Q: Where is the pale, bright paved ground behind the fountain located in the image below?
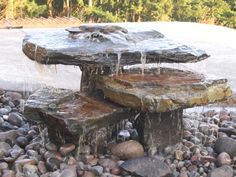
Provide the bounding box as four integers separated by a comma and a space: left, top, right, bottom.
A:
0, 22, 236, 91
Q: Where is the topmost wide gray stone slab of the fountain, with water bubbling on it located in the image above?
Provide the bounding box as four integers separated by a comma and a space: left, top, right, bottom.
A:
23, 25, 209, 66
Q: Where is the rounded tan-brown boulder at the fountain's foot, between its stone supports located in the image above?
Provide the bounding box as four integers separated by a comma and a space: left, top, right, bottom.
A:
111, 140, 144, 160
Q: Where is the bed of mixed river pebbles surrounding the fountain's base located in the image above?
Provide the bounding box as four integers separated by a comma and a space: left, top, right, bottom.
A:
0, 90, 236, 177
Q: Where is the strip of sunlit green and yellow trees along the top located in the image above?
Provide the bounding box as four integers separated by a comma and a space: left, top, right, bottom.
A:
0, 0, 236, 28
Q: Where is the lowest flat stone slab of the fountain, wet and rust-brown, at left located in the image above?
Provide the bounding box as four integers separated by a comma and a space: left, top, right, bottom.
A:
25, 88, 128, 135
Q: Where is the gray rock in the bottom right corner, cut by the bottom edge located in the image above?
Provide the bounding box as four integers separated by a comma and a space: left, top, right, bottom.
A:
210, 165, 233, 177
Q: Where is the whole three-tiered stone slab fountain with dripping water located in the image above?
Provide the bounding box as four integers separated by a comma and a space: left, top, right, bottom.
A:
23, 25, 231, 152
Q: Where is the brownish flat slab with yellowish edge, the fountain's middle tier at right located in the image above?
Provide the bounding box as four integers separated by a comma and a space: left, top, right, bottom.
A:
96, 68, 232, 112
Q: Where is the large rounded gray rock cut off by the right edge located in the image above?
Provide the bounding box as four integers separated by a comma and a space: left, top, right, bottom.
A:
215, 137, 236, 157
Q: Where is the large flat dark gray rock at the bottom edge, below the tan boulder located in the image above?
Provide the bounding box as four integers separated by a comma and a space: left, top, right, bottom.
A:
120, 157, 171, 177
